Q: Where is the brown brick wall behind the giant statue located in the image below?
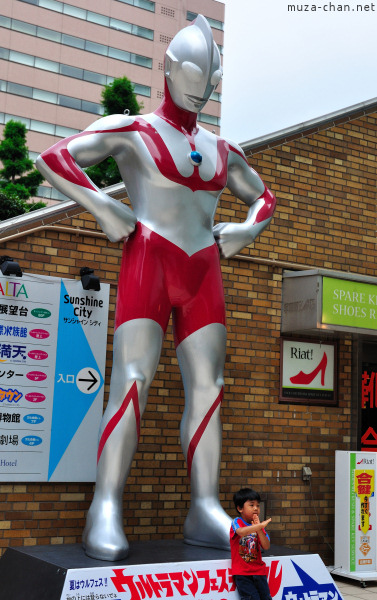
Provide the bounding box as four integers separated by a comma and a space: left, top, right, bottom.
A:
0, 114, 377, 564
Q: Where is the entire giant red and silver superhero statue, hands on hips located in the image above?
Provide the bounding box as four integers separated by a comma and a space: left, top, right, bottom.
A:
37, 15, 275, 560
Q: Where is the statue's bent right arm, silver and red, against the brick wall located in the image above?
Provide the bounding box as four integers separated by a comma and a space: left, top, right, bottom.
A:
213, 145, 276, 258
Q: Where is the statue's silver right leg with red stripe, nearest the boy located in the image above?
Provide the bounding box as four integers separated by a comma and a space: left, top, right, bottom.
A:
177, 323, 231, 549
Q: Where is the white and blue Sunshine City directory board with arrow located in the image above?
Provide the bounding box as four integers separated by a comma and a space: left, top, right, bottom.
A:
0, 275, 109, 481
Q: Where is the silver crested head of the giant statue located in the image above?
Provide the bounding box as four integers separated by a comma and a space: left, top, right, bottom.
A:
165, 15, 222, 113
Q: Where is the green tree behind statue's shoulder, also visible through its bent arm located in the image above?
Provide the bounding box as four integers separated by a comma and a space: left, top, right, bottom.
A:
85, 77, 143, 187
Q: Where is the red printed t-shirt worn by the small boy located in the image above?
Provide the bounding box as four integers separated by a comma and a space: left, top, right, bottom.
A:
230, 517, 268, 575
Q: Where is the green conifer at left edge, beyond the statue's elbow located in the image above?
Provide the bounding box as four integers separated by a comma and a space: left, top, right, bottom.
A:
0, 121, 43, 200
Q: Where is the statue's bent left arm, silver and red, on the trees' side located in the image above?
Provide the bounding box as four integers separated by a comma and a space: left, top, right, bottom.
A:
36, 115, 136, 242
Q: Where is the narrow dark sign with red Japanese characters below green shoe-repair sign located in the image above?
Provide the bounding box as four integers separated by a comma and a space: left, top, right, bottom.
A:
360, 363, 377, 452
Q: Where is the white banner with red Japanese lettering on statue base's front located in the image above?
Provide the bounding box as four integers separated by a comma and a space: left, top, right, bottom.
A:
61, 542, 342, 600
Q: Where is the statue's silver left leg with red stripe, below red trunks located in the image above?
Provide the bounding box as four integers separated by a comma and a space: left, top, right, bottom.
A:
83, 319, 164, 560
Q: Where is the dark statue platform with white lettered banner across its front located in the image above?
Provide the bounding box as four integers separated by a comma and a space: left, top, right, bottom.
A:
0, 540, 341, 600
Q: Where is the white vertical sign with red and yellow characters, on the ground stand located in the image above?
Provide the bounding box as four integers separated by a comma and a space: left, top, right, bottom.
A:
350, 453, 376, 572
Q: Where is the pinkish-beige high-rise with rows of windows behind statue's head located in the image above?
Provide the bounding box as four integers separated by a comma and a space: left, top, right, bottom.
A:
0, 0, 224, 203
